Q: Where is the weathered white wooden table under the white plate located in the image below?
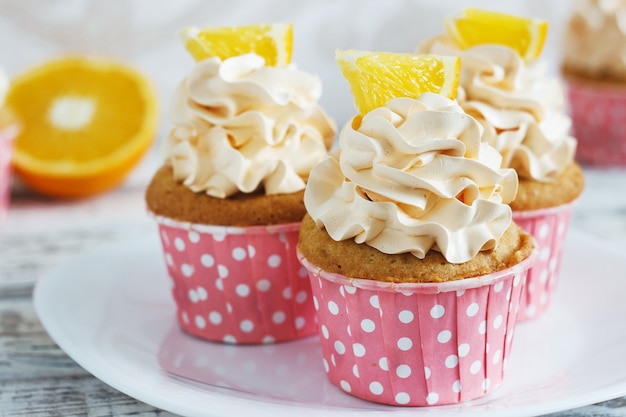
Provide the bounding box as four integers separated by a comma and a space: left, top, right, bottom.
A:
0, 150, 626, 417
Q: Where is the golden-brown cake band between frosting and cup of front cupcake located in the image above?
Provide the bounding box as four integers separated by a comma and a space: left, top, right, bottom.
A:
298, 214, 533, 283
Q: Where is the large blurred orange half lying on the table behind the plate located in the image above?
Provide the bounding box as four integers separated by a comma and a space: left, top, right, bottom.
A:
6, 56, 157, 197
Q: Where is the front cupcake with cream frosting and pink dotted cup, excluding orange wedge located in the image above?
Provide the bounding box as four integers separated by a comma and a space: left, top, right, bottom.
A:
298, 50, 533, 406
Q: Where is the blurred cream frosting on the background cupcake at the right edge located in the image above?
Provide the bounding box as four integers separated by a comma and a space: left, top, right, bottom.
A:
563, 0, 626, 81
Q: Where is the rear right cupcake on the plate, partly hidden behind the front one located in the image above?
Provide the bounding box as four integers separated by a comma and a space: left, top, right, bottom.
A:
418, 12, 584, 320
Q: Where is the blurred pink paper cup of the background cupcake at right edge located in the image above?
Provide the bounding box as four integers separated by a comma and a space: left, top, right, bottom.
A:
568, 81, 626, 167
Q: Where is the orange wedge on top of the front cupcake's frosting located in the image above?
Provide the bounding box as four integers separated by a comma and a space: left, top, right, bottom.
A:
335, 49, 461, 115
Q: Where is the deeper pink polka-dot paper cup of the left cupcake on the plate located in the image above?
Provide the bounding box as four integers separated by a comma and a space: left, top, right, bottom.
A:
155, 213, 317, 344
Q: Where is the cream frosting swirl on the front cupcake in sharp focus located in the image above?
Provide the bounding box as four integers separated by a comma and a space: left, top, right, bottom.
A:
304, 93, 517, 263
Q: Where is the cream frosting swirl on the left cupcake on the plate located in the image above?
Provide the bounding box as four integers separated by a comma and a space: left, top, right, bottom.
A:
163, 54, 336, 198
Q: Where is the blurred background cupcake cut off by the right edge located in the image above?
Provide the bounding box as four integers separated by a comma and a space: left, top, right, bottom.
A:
561, 0, 626, 168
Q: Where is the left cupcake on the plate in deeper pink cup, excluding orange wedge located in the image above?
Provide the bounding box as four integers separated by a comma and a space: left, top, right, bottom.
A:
145, 26, 335, 344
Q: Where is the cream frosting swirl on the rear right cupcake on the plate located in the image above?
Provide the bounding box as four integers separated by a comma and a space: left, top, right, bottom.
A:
419, 36, 576, 182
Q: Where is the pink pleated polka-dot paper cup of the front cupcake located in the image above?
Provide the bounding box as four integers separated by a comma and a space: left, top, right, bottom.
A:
301, 252, 533, 406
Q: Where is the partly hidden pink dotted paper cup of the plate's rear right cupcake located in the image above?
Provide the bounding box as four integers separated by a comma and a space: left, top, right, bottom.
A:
513, 203, 574, 321
